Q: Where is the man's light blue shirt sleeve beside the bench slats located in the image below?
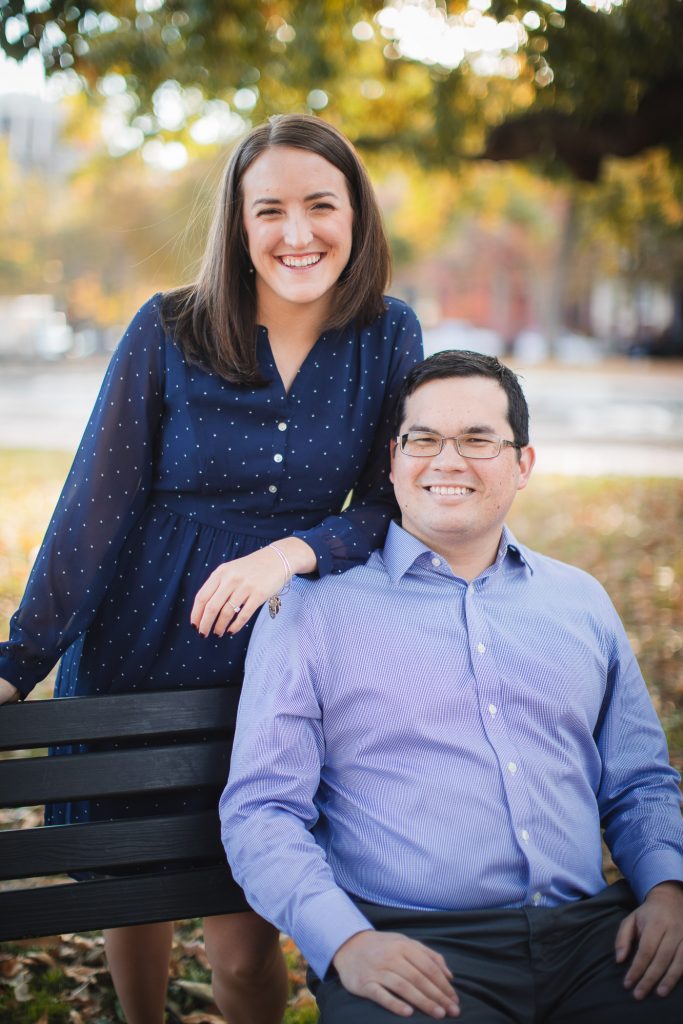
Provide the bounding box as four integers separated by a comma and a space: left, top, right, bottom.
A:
220, 581, 372, 978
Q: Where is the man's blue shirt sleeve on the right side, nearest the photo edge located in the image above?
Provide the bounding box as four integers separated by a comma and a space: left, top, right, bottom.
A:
596, 604, 683, 901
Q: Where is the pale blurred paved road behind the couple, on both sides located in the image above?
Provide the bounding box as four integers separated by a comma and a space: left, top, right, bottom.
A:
0, 359, 683, 478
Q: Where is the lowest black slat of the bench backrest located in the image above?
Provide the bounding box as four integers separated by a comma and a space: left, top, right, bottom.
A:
0, 865, 244, 941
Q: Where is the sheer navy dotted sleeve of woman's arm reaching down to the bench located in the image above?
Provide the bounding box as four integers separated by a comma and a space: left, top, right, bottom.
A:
0, 299, 164, 696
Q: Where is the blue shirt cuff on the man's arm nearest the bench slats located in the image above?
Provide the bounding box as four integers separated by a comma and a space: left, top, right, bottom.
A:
292, 889, 374, 979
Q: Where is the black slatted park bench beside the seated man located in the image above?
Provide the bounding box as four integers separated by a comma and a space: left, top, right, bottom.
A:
0, 689, 242, 941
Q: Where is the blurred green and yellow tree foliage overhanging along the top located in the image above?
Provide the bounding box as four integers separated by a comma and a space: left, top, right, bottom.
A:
5, 0, 683, 180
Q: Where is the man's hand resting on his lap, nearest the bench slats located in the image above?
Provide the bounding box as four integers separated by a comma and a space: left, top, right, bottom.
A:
333, 931, 460, 1020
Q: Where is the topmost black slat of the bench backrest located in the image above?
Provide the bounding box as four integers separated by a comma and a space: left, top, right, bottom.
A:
0, 687, 240, 751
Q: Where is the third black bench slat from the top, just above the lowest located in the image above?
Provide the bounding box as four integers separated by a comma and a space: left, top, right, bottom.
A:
0, 815, 225, 879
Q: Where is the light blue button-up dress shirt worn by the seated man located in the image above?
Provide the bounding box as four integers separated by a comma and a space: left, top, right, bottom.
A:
220, 523, 683, 977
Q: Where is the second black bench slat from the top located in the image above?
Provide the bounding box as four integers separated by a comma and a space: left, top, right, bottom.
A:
0, 737, 230, 807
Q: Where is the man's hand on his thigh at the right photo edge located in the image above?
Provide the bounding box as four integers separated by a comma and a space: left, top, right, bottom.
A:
614, 882, 683, 999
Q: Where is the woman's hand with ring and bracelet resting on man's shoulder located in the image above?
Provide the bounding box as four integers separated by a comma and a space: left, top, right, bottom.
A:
189, 537, 316, 637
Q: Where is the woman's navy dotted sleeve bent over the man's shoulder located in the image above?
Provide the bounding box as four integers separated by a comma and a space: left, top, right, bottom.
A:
294, 303, 423, 575
